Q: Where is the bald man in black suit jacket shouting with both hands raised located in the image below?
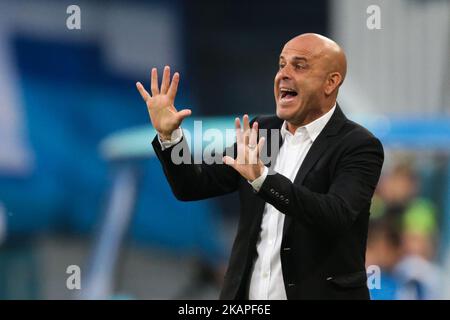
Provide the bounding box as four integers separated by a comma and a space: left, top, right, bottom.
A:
137, 34, 384, 300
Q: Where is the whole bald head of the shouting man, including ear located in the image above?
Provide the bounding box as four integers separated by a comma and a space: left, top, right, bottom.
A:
274, 33, 347, 127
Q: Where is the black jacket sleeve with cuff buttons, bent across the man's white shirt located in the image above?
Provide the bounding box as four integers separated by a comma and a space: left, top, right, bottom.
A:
258, 136, 384, 234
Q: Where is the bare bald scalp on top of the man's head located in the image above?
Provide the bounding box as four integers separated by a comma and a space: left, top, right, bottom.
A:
283, 33, 347, 85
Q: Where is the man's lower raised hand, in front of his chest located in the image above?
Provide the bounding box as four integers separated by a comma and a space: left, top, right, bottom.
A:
223, 115, 264, 181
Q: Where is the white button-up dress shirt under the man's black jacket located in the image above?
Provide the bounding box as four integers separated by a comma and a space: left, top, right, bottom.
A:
248, 105, 336, 300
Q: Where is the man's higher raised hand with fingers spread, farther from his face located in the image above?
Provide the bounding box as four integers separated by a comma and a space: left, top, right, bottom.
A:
136, 66, 192, 140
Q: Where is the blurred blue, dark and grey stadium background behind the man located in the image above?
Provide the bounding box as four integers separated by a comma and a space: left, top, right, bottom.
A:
0, 0, 450, 299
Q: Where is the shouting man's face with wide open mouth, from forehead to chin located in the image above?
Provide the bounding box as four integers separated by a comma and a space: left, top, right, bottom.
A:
274, 43, 325, 125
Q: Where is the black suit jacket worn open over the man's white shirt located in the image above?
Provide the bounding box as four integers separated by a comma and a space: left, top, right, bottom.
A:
152, 106, 384, 299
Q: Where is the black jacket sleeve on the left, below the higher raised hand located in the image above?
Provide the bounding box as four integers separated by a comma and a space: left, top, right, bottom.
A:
152, 132, 239, 201
